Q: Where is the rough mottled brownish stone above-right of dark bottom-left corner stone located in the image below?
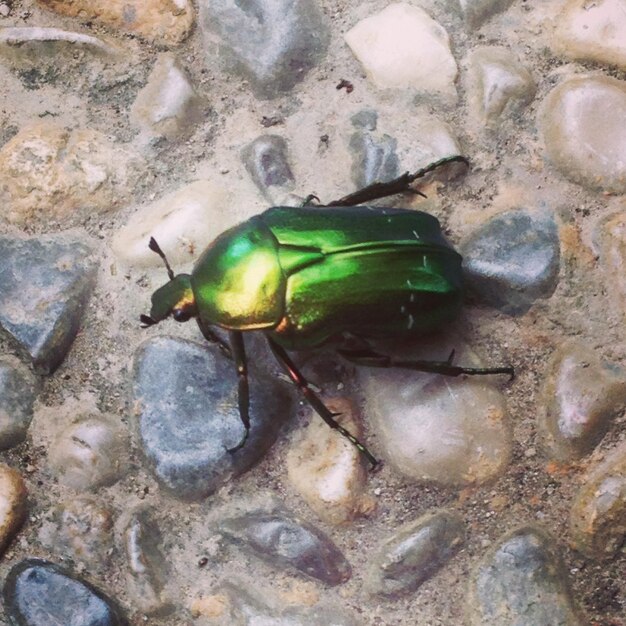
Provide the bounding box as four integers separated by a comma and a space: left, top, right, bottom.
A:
38, 496, 114, 572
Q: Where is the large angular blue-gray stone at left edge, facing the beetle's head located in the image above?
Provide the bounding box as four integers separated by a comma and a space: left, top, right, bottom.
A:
0, 233, 96, 374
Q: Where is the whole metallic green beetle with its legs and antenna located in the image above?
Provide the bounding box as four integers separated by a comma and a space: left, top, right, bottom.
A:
141, 156, 513, 466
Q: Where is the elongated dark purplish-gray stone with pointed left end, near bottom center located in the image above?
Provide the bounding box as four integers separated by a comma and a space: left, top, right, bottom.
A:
220, 511, 350, 586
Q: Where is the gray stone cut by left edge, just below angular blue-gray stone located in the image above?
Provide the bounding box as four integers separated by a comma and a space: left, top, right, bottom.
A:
0, 357, 39, 450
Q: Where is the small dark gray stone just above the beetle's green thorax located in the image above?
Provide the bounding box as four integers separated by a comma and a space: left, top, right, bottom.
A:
241, 135, 294, 201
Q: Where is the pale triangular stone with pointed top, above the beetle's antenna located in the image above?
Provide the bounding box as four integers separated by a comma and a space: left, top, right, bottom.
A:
130, 52, 202, 140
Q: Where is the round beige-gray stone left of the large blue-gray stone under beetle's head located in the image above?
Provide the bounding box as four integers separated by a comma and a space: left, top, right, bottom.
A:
50, 416, 129, 491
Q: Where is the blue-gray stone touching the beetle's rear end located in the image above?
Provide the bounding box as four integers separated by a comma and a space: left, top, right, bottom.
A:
461, 210, 560, 315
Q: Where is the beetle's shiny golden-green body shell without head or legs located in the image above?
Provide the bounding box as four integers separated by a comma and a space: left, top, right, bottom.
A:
191, 206, 461, 349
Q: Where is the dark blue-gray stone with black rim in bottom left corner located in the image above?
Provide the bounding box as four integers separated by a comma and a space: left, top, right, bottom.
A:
2, 559, 128, 626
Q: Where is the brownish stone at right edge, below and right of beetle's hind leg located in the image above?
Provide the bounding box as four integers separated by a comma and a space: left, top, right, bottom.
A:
539, 344, 626, 461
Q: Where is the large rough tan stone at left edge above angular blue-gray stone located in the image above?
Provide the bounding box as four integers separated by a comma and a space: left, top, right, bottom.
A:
0, 122, 140, 227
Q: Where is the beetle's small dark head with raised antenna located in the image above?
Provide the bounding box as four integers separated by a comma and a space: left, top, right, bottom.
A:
140, 238, 197, 328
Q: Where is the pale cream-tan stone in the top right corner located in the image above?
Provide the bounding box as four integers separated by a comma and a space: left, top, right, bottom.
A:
550, 0, 626, 69
